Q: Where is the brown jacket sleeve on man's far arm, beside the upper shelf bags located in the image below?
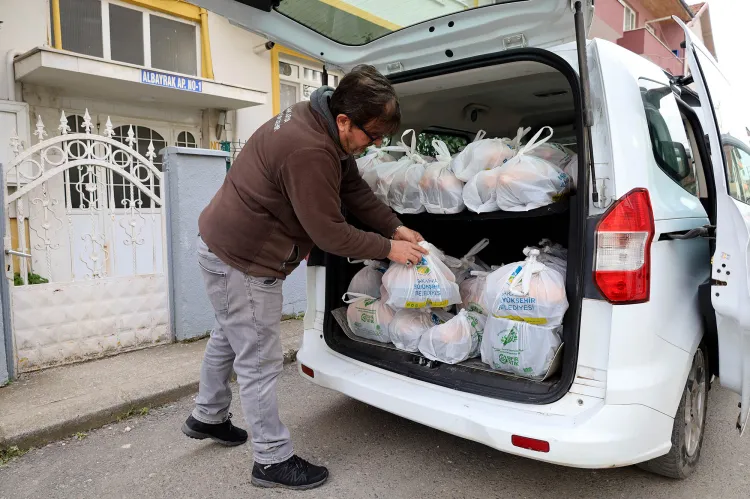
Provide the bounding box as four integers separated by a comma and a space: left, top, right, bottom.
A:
341, 161, 401, 237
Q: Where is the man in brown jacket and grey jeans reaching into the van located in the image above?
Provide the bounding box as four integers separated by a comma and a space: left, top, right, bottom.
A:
182, 66, 426, 489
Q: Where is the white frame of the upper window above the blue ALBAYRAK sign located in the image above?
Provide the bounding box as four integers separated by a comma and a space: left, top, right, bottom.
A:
53, 0, 203, 78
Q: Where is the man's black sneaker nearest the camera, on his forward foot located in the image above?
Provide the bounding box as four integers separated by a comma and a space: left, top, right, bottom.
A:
250, 455, 328, 490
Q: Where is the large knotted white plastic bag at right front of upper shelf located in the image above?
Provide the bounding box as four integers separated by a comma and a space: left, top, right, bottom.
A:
496, 126, 570, 211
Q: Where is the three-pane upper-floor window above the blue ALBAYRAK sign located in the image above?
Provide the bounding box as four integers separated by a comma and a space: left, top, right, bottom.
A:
50, 0, 200, 76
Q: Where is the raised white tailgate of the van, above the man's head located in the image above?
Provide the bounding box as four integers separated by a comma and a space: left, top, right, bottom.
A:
193, 0, 594, 74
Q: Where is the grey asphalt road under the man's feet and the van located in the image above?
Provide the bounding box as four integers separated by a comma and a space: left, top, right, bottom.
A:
0, 366, 750, 499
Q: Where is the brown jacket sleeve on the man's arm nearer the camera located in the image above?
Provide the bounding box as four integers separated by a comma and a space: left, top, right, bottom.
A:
279, 148, 391, 260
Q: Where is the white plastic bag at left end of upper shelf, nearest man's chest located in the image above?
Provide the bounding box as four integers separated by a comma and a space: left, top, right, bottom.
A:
376, 130, 427, 214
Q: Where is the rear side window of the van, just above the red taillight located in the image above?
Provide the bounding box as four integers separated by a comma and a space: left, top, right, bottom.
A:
638, 79, 698, 196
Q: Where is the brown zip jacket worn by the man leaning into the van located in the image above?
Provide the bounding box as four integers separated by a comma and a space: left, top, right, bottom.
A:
198, 97, 400, 279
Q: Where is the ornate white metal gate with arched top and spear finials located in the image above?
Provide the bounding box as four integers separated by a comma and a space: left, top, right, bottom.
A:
2, 111, 170, 372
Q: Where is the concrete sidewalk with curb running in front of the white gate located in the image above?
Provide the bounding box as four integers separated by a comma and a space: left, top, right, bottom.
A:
0, 320, 303, 449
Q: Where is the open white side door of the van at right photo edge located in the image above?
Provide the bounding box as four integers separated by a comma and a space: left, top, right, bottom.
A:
677, 20, 750, 433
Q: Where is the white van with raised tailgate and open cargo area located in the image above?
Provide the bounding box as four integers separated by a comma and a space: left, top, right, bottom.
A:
196, 0, 750, 478
